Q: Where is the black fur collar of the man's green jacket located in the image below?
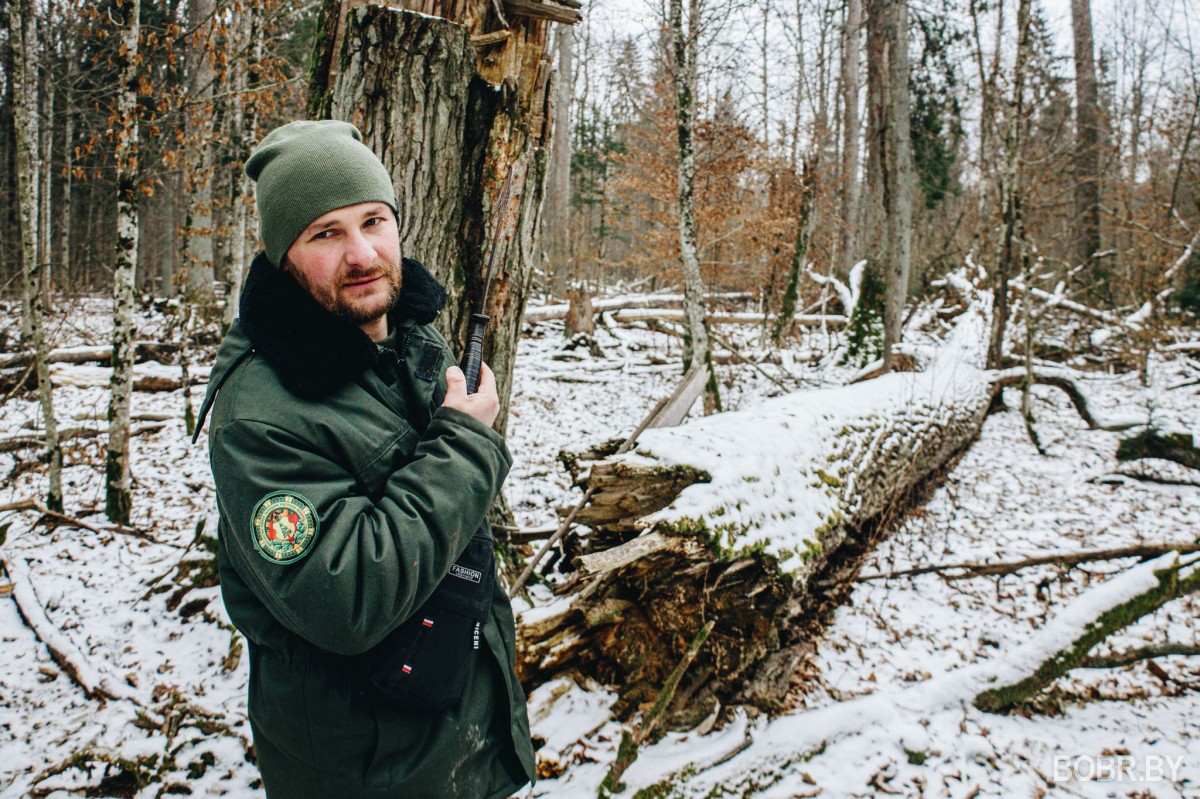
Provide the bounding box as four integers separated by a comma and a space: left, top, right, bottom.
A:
238, 253, 446, 398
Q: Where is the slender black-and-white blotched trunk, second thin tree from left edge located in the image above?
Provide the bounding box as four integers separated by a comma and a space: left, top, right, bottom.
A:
104, 0, 142, 524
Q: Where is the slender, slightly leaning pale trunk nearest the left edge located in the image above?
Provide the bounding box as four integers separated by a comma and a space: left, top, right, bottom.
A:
8, 0, 62, 511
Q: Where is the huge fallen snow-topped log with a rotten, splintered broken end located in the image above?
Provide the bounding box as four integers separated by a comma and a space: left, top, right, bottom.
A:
521, 307, 995, 717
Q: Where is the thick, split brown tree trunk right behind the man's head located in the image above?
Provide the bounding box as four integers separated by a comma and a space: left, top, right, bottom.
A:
308, 0, 573, 432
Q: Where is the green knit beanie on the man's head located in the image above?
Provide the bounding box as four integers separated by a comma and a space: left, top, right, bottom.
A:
246, 120, 397, 266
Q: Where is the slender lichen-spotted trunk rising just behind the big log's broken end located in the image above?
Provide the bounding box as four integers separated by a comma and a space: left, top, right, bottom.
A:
668, 0, 721, 413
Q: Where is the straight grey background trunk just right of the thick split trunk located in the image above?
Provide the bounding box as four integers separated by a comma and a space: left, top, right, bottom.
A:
542, 28, 575, 283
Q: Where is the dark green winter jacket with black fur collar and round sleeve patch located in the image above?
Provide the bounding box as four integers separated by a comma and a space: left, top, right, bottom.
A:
197, 250, 534, 799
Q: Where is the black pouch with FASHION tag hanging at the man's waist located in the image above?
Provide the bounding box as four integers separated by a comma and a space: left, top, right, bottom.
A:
362, 522, 496, 710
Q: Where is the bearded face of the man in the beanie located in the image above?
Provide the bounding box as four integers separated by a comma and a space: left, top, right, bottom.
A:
283, 203, 401, 325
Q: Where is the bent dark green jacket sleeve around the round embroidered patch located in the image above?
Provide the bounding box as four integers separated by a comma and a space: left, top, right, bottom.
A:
210, 407, 512, 655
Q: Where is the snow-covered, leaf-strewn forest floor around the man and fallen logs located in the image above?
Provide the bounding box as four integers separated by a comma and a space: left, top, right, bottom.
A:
0, 300, 1200, 798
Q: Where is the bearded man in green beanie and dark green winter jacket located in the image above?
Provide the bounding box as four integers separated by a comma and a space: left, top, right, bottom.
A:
190, 121, 534, 799
